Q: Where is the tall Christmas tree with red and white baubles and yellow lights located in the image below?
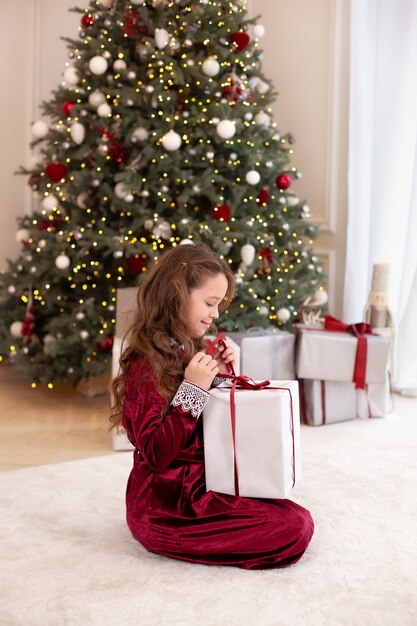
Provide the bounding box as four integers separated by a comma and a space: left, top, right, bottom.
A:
0, 0, 326, 385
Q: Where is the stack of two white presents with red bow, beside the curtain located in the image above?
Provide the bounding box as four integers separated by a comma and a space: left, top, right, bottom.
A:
296, 316, 390, 426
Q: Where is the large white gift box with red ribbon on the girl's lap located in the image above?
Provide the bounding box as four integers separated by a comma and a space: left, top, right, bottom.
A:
203, 380, 301, 499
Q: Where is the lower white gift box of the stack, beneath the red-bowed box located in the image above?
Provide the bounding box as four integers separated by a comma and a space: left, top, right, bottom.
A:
299, 379, 389, 426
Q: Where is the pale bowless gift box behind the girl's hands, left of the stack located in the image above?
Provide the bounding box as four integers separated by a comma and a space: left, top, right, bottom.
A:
241, 331, 295, 380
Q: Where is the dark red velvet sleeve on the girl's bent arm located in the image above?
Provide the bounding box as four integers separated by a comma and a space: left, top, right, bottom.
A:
123, 360, 206, 472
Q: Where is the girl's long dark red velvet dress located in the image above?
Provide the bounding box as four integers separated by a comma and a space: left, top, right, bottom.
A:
123, 359, 314, 569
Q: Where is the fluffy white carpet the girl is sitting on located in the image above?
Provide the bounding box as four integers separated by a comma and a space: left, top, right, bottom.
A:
0, 400, 417, 626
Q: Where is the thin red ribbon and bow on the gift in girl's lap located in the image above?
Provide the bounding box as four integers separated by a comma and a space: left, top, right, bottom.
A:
214, 339, 295, 496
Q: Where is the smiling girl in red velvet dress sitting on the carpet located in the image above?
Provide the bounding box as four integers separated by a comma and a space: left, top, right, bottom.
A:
111, 244, 313, 569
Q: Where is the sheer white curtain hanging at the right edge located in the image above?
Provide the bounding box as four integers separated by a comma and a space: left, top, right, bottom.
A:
344, 0, 417, 390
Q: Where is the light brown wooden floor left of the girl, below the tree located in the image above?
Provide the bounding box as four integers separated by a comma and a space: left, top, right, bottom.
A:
0, 365, 117, 471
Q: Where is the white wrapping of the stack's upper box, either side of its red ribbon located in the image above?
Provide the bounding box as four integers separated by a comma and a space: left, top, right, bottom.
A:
296, 329, 390, 384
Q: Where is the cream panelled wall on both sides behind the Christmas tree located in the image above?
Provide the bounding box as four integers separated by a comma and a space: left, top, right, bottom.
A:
0, 0, 349, 315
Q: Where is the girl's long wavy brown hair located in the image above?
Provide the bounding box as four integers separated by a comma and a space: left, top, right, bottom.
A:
110, 244, 235, 427
